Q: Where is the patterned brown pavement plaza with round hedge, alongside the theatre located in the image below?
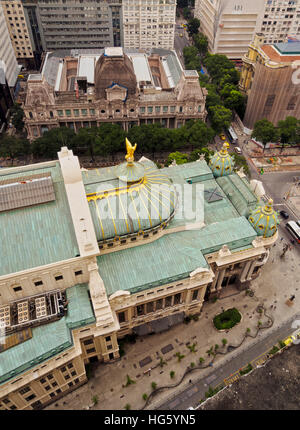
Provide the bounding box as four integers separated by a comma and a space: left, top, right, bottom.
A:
46, 237, 300, 410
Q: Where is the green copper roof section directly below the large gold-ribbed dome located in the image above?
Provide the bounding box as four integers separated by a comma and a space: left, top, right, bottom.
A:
97, 233, 208, 296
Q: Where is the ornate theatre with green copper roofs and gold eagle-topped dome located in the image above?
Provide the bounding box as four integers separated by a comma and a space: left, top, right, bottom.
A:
0, 137, 278, 410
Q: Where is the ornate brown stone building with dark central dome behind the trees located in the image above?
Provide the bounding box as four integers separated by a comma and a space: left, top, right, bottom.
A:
24, 48, 206, 140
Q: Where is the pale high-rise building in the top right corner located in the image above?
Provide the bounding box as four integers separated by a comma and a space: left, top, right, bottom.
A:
195, 0, 300, 59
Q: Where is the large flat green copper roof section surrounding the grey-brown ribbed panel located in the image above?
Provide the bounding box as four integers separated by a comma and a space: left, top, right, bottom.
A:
0, 163, 79, 276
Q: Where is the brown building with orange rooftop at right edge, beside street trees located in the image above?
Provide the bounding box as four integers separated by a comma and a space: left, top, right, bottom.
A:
239, 33, 300, 130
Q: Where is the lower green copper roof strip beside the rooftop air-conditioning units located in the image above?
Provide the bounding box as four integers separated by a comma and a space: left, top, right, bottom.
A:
0, 284, 95, 384
